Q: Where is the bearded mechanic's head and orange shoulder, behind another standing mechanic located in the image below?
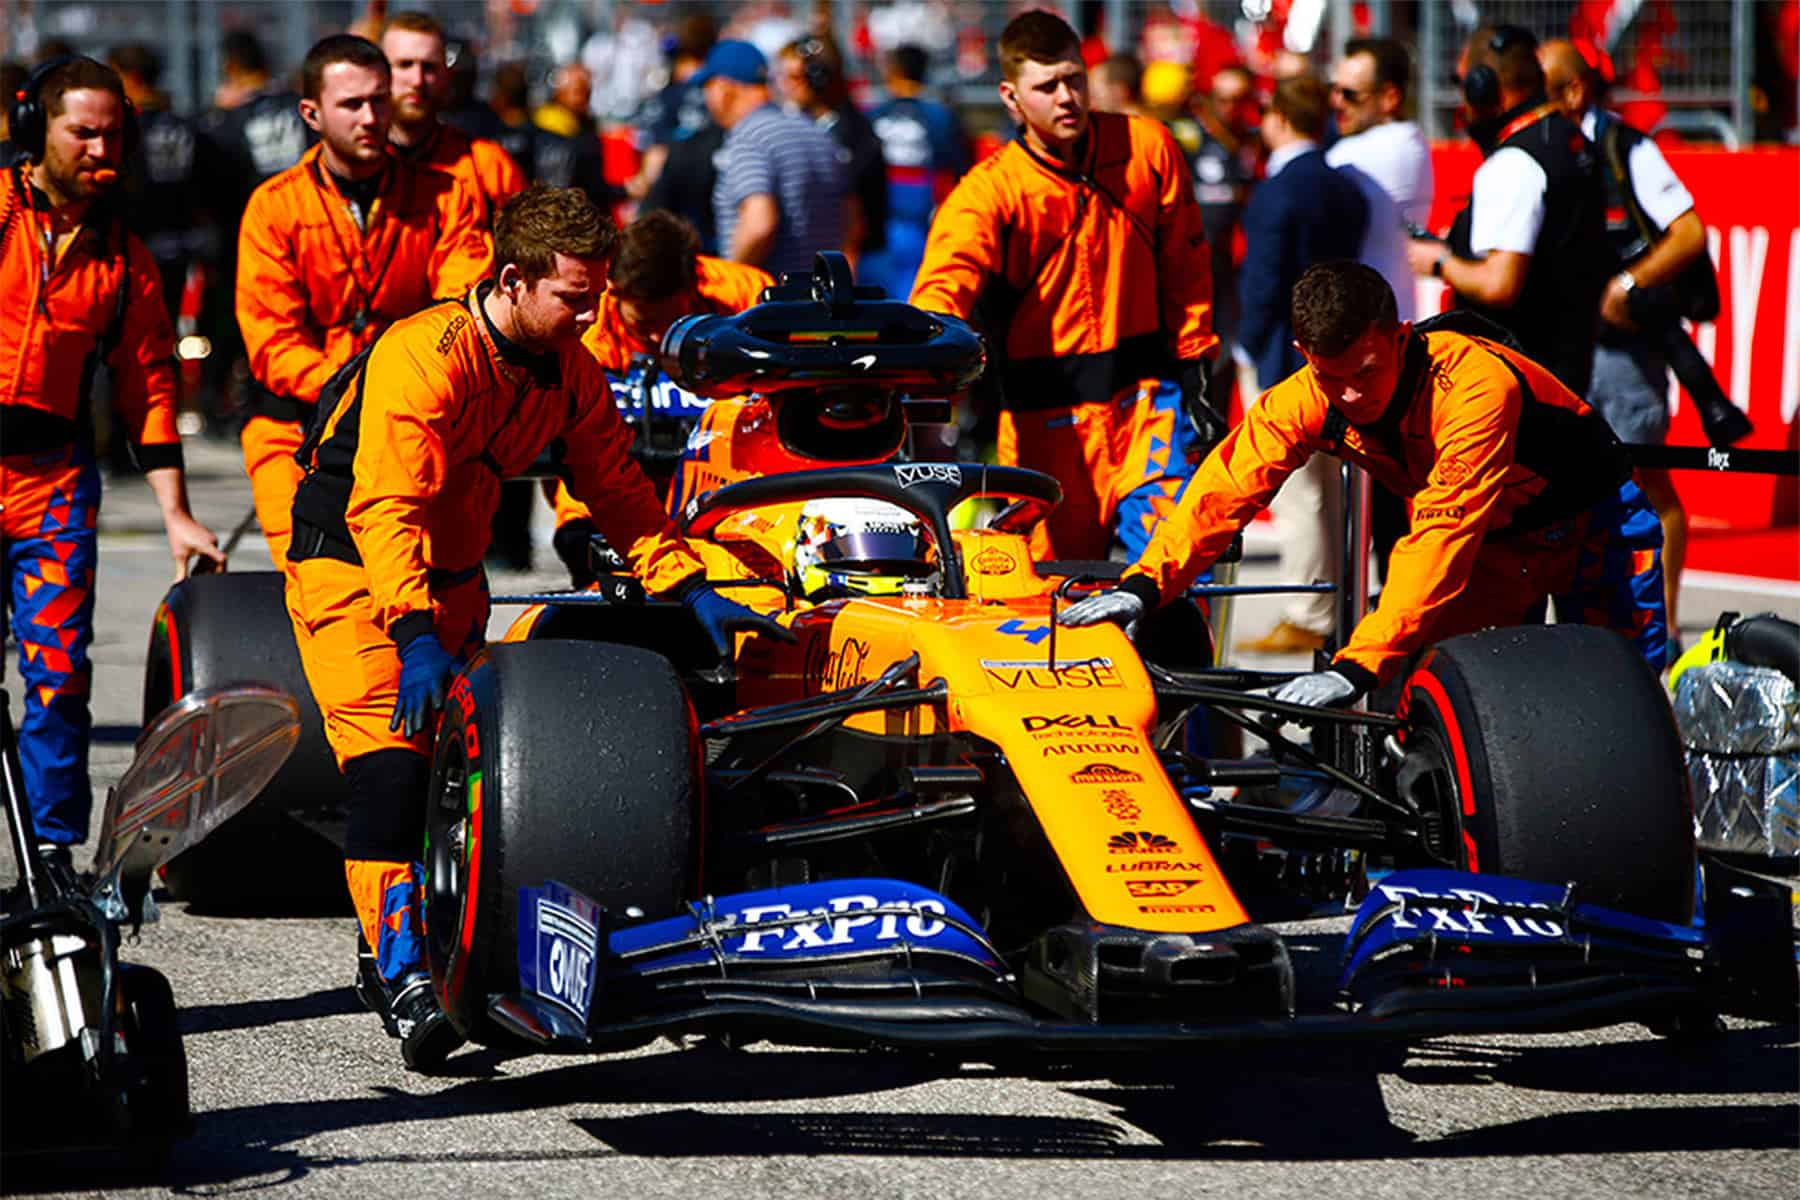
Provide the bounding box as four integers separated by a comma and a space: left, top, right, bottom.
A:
382, 13, 526, 227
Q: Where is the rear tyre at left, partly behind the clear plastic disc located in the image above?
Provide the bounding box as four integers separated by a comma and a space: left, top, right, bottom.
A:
144, 570, 347, 912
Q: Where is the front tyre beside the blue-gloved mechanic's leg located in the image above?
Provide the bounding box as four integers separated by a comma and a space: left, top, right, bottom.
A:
425, 640, 700, 1045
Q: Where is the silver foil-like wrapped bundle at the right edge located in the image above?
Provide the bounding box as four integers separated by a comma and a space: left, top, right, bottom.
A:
1676, 662, 1800, 856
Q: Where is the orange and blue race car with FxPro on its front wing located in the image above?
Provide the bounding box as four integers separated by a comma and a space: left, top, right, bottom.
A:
136, 255, 1795, 1052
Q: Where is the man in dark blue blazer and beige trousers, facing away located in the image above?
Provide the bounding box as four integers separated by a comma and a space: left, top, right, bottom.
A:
1238, 76, 1368, 653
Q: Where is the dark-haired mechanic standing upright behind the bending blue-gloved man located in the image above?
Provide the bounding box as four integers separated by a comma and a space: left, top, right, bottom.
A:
238, 34, 493, 567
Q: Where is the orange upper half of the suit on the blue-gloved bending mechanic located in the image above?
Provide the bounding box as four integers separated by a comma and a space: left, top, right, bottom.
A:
290, 284, 702, 630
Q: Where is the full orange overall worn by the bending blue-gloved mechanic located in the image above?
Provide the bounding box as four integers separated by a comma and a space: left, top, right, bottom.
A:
286, 284, 702, 982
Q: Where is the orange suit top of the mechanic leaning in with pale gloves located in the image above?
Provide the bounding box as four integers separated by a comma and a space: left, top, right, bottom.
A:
1125, 331, 1629, 684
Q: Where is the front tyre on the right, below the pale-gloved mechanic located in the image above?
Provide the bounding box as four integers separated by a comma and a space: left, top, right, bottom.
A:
1397, 624, 1694, 923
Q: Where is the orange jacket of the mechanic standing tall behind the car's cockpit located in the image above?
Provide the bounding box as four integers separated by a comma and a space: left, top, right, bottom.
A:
913, 113, 1219, 410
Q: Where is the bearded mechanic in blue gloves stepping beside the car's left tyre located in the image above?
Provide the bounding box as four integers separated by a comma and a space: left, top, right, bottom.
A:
286, 187, 792, 1069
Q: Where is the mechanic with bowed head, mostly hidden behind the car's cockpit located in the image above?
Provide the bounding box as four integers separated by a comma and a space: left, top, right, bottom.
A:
554, 210, 774, 587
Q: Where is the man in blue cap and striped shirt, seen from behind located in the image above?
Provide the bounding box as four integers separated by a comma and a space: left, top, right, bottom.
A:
693, 41, 850, 277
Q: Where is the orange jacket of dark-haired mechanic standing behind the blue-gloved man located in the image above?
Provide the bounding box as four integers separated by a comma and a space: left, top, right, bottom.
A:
238, 146, 493, 405
